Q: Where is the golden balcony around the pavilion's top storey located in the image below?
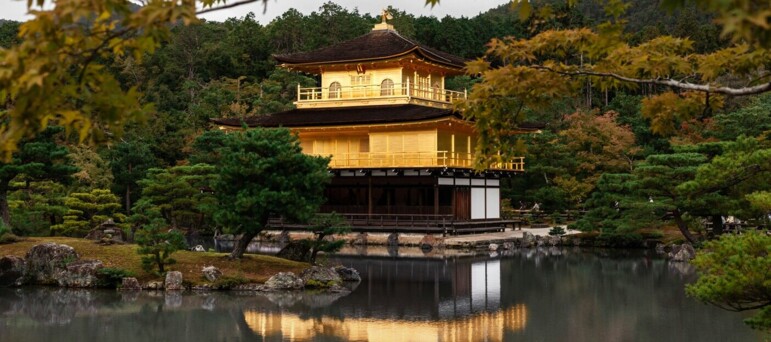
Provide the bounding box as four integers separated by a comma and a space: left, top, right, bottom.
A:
295, 82, 466, 108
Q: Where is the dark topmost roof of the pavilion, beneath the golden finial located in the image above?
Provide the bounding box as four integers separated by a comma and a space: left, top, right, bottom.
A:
273, 30, 466, 69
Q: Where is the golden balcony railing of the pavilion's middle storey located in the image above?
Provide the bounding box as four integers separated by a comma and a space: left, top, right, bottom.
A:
314, 151, 525, 172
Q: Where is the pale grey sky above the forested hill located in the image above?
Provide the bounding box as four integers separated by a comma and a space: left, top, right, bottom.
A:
0, 0, 510, 25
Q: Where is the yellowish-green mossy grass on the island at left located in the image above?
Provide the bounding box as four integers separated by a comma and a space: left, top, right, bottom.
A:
0, 237, 308, 284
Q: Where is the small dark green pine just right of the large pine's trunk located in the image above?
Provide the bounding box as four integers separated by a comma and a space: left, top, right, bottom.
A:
306, 212, 351, 265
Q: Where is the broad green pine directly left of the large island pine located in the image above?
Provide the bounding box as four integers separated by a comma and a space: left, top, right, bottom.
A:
132, 164, 216, 234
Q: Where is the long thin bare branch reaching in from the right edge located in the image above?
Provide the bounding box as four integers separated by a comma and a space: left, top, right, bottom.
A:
529, 65, 771, 96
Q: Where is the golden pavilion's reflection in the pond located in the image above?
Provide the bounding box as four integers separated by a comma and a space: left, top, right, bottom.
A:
244, 258, 528, 341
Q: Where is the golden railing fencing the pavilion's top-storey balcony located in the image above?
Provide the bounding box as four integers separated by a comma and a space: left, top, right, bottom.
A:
297, 82, 466, 103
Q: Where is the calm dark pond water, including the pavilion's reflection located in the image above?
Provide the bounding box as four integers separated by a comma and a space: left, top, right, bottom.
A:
0, 249, 768, 342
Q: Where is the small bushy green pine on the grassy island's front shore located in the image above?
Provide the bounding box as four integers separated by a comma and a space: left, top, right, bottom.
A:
134, 213, 186, 274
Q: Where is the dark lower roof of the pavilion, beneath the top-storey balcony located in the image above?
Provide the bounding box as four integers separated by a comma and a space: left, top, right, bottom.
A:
211, 104, 460, 127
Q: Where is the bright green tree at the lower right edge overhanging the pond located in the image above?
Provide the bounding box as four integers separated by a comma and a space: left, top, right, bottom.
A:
686, 232, 771, 330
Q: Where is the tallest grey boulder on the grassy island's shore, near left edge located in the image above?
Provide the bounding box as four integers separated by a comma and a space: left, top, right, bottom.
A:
24, 243, 80, 285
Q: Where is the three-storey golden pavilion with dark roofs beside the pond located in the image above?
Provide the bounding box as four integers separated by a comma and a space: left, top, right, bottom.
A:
213, 13, 527, 233
